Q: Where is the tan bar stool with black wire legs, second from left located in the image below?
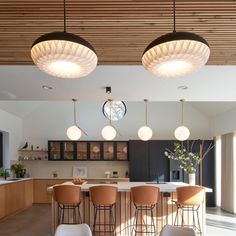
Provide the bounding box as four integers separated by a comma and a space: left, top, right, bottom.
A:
89, 185, 117, 235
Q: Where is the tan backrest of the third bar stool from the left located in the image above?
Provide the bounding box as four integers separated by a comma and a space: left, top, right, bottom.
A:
131, 185, 160, 205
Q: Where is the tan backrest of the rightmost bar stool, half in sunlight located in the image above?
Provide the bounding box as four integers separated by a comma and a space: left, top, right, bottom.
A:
176, 186, 205, 205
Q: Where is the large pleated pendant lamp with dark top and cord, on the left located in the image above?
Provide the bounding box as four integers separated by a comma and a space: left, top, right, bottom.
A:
31, 0, 98, 79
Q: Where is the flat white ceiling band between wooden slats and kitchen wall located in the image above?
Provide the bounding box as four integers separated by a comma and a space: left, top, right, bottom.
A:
0, 66, 236, 101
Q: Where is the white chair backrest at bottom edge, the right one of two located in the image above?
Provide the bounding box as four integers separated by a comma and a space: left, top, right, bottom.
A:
160, 225, 196, 236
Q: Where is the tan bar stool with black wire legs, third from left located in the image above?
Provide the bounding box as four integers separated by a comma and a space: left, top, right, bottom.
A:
131, 186, 160, 235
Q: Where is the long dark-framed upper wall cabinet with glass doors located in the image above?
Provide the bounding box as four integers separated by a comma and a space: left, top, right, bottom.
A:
48, 140, 128, 161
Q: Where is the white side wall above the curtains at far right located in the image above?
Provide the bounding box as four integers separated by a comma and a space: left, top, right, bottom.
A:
211, 108, 236, 136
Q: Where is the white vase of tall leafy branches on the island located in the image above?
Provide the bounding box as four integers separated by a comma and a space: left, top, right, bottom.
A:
165, 141, 214, 185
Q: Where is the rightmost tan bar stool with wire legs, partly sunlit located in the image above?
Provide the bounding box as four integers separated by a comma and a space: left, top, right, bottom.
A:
174, 186, 205, 235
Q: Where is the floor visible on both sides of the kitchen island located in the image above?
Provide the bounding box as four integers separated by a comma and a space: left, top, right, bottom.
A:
0, 204, 236, 236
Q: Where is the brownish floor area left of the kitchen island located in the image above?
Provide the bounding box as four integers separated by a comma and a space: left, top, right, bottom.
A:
0, 204, 51, 236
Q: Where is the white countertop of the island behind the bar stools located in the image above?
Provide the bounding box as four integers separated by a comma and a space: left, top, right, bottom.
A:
48, 182, 212, 192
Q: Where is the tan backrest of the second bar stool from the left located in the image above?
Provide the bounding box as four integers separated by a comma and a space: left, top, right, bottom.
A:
89, 185, 117, 206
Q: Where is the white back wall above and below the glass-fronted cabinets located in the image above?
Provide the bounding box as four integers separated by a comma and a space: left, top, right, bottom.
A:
19, 101, 210, 177
